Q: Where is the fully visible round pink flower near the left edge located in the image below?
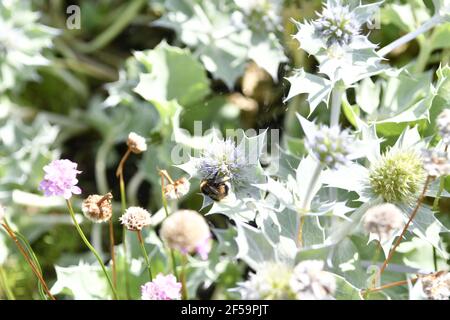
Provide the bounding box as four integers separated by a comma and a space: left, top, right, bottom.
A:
39, 159, 81, 199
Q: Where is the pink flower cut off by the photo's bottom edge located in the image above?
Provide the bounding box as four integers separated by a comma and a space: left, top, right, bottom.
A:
141, 273, 181, 300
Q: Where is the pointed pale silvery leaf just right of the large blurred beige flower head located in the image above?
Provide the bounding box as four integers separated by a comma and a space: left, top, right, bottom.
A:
236, 221, 276, 270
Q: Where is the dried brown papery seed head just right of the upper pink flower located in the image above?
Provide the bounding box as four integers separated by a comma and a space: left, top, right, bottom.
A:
81, 192, 113, 223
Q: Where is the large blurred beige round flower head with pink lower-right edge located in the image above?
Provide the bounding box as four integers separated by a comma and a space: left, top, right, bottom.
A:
160, 210, 211, 259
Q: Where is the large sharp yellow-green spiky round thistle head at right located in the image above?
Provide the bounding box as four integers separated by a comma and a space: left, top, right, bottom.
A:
369, 150, 426, 203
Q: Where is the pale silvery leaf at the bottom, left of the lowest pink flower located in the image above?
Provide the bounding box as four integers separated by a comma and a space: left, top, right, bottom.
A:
50, 262, 111, 300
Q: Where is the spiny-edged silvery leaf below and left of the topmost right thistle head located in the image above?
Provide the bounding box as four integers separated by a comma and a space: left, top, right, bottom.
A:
284, 69, 333, 115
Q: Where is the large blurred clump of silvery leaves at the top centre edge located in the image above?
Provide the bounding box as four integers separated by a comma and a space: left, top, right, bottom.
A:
153, 0, 286, 88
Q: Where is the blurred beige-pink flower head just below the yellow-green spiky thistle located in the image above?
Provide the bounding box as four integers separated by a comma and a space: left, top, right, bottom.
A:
364, 203, 403, 242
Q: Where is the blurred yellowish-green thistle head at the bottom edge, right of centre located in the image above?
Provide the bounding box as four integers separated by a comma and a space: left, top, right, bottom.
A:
237, 262, 295, 300
